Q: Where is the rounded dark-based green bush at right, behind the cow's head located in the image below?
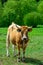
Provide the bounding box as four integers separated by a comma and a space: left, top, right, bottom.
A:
23, 12, 42, 27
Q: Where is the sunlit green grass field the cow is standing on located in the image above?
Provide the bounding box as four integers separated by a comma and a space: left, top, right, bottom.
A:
0, 28, 43, 65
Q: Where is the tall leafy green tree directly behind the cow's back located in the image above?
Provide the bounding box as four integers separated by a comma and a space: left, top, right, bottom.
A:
2, 1, 23, 26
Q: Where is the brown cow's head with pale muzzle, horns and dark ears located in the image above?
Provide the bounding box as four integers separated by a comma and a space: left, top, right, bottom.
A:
17, 26, 32, 41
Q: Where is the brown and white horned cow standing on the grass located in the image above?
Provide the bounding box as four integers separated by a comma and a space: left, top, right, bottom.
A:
6, 23, 32, 61
